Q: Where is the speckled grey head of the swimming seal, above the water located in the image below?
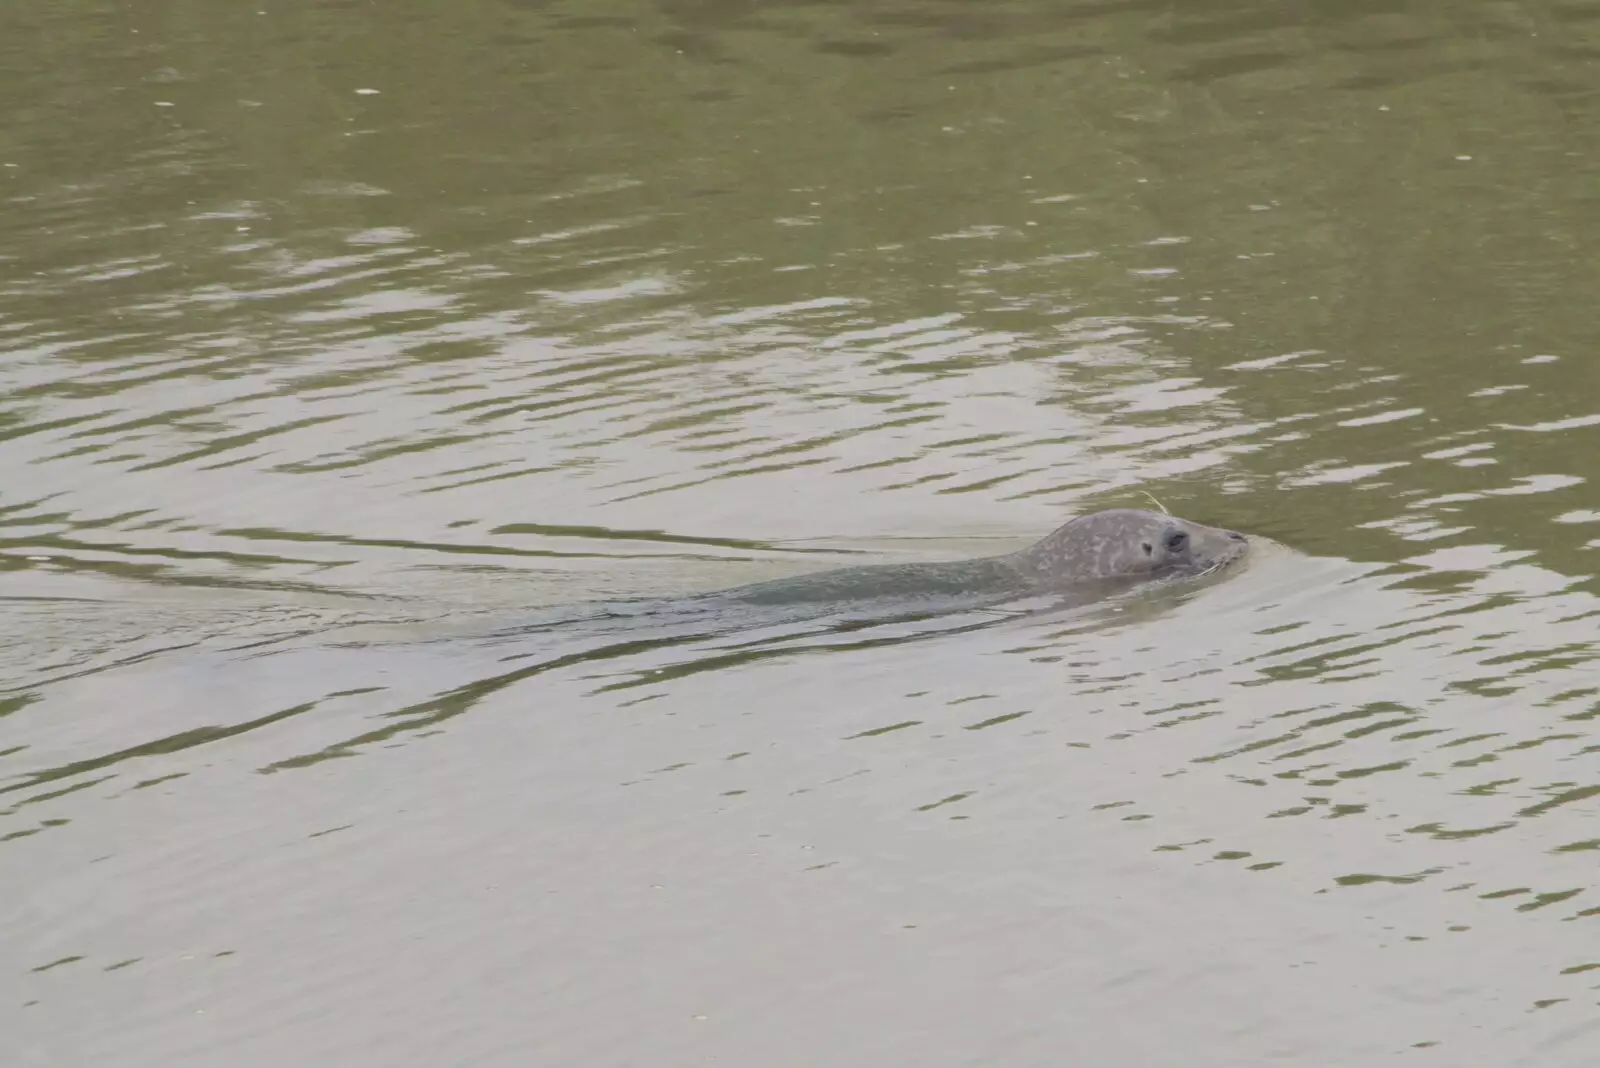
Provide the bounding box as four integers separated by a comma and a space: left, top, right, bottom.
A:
1013, 508, 1250, 590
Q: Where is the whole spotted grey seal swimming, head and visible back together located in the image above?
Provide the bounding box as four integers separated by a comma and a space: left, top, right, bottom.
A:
715, 508, 1250, 604
